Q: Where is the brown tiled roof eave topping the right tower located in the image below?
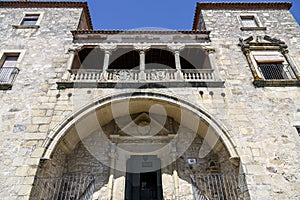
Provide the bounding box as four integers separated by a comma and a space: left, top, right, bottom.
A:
193, 2, 292, 30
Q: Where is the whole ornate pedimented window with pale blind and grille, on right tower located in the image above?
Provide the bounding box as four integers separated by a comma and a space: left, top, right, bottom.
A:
240, 36, 300, 86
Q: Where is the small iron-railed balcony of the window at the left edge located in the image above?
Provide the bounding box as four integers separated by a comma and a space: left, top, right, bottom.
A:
0, 67, 20, 90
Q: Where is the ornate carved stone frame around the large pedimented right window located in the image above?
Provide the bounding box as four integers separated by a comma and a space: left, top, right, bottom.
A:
240, 36, 300, 87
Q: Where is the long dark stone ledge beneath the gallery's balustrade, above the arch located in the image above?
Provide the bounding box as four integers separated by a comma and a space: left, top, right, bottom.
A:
56, 81, 224, 89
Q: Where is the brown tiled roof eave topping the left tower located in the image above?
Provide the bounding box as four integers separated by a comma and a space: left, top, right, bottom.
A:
0, 1, 93, 29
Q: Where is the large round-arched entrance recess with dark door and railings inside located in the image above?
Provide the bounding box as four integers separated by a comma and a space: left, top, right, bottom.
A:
32, 92, 246, 199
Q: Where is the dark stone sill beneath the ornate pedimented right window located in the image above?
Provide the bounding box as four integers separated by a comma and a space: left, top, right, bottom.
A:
253, 80, 300, 87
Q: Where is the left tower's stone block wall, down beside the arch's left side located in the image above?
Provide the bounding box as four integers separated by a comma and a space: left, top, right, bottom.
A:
0, 8, 82, 199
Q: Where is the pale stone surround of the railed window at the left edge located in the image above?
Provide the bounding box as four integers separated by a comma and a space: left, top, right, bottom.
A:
0, 50, 25, 90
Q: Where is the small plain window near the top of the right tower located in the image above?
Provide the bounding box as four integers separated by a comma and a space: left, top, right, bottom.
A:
239, 15, 266, 31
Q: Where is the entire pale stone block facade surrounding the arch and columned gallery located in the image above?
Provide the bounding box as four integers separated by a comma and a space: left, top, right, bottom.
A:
0, 3, 300, 199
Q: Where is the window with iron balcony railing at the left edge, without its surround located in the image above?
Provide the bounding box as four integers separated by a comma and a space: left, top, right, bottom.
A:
0, 53, 20, 89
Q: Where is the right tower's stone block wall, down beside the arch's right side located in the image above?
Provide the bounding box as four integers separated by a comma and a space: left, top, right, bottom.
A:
197, 9, 300, 199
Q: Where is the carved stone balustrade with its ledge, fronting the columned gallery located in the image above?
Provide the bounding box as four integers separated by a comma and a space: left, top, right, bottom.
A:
57, 69, 223, 88
